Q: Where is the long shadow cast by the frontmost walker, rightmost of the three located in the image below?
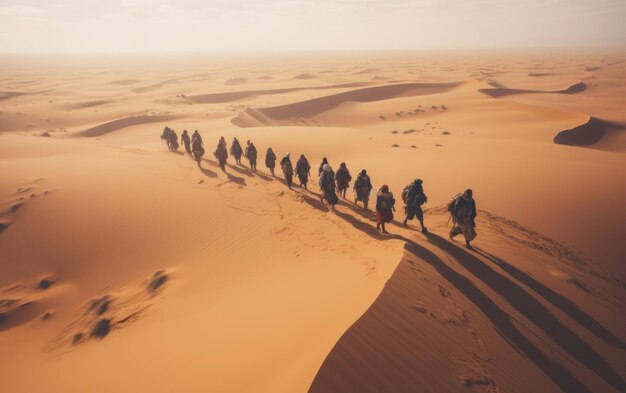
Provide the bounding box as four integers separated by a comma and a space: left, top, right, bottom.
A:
476, 249, 626, 349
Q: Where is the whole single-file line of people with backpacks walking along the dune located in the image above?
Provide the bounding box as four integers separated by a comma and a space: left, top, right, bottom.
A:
161, 127, 476, 248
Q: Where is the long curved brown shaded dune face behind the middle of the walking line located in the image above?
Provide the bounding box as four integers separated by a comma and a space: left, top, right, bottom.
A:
232, 83, 459, 127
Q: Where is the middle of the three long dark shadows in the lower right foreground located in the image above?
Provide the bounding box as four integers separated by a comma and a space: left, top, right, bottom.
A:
427, 233, 626, 392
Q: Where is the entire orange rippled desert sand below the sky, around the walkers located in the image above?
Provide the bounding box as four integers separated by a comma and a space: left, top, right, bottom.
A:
0, 51, 626, 393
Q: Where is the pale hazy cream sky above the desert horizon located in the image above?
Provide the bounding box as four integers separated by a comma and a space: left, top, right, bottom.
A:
0, 0, 626, 52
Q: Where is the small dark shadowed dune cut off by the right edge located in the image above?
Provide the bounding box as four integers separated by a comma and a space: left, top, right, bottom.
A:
554, 117, 626, 151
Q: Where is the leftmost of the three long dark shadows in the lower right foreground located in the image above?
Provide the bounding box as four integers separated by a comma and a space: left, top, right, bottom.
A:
404, 235, 591, 393
